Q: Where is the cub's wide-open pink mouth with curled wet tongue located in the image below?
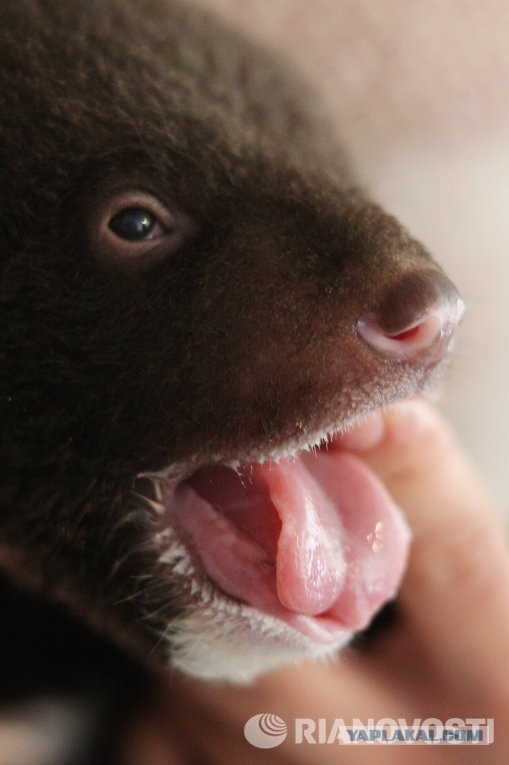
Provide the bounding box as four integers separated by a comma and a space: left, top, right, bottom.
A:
153, 424, 410, 645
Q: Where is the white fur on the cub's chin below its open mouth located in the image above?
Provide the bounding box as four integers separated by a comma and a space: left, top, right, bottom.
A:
149, 502, 351, 683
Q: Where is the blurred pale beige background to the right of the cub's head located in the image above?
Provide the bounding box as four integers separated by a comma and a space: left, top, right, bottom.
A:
200, 0, 509, 513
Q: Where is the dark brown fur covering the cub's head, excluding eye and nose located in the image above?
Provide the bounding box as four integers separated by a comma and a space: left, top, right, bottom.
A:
0, 0, 450, 760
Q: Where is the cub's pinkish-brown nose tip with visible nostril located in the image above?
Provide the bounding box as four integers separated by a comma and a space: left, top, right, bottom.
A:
357, 271, 465, 364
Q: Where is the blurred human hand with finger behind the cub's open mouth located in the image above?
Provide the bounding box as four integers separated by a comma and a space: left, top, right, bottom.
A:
122, 399, 509, 765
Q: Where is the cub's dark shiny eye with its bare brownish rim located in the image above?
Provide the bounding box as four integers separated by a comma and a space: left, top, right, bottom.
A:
90, 189, 196, 262
